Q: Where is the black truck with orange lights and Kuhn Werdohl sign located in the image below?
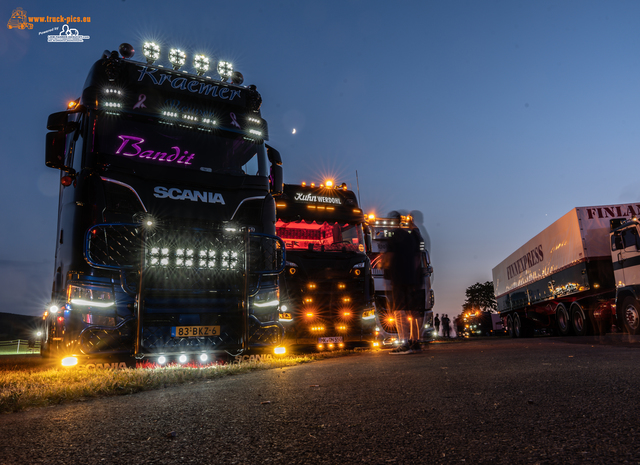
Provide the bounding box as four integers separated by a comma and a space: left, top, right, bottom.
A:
276, 181, 376, 350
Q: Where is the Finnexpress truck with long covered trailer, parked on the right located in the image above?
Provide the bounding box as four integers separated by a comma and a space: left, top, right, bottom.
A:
493, 204, 640, 337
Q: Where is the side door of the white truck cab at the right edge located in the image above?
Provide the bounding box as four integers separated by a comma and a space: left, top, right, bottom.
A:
611, 225, 640, 287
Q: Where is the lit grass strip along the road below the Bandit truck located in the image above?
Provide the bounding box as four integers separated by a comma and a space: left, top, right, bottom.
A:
0, 351, 353, 413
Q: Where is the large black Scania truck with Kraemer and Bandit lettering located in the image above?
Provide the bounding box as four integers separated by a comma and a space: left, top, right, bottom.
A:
42, 43, 285, 366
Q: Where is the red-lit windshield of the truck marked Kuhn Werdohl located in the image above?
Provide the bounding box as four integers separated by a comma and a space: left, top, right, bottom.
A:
276, 220, 364, 252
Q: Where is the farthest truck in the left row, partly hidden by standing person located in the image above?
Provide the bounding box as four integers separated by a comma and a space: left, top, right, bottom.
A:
367, 215, 435, 346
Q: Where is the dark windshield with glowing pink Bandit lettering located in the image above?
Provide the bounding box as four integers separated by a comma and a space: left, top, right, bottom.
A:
93, 114, 269, 176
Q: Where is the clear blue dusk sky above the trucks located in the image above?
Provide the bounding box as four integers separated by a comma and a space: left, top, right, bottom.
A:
0, 0, 640, 316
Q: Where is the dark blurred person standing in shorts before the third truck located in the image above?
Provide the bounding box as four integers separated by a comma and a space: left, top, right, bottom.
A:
384, 211, 422, 354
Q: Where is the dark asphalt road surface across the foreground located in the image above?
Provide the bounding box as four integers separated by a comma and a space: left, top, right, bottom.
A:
0, 337, 640, 464
